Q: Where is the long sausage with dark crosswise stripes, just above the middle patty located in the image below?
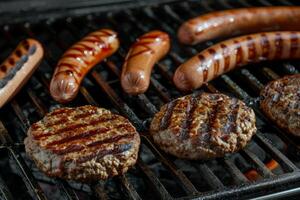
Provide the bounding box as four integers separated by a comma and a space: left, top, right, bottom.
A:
173, 32, 300, 91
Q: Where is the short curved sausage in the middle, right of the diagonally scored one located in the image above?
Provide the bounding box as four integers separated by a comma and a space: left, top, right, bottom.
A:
121, 31, 170, 95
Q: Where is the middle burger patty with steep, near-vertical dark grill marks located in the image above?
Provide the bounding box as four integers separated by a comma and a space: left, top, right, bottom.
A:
150, 93, 256, 160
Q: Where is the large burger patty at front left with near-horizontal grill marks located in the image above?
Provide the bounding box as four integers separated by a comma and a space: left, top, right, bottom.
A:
24, 106, 140, 181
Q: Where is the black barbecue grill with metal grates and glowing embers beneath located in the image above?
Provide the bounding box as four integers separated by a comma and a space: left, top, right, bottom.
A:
0, 0, 300, 200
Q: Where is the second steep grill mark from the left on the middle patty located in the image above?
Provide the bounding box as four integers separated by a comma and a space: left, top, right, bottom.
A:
179, 94, 199, 140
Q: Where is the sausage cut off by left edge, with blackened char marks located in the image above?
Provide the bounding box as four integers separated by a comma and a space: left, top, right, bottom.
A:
0, 39, 44, 108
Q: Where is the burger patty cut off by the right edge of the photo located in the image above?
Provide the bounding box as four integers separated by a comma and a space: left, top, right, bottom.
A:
260, 74, 300, 136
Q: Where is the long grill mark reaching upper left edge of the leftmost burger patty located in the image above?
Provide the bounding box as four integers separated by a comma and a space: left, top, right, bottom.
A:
34, 116, 117, 140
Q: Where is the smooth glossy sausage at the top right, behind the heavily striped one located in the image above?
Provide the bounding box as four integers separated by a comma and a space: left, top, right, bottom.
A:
178, 6, 300, 45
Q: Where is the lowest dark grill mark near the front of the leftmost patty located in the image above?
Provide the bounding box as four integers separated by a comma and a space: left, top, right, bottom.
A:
77, 143, 132, 163
